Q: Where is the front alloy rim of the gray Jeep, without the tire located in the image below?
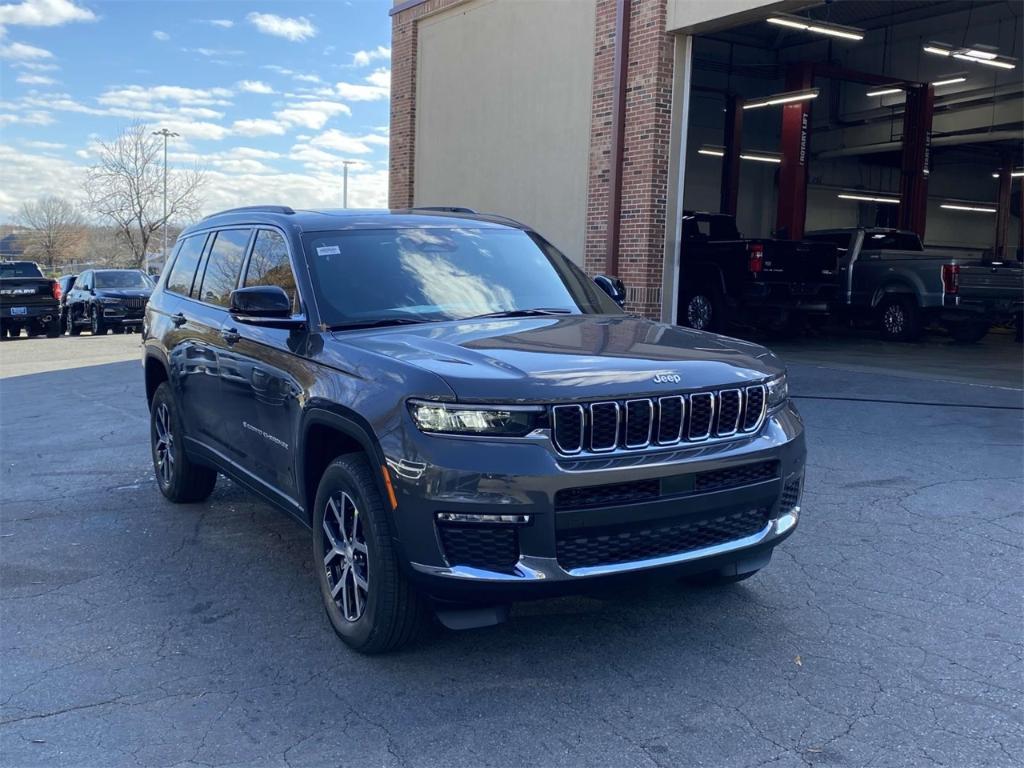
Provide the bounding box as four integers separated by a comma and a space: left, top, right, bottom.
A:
324, 490, 370, 622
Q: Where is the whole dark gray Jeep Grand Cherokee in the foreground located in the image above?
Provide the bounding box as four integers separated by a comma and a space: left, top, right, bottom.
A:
143, 207, 805, 652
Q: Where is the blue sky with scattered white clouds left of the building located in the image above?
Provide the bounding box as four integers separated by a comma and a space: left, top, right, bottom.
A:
0, 0, 391, 221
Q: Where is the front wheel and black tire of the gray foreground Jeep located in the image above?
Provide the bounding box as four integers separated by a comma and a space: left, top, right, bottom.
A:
312, 454, 428, 654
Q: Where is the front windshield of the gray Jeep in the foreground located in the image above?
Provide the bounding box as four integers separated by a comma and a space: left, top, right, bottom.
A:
303, 227, 621, 327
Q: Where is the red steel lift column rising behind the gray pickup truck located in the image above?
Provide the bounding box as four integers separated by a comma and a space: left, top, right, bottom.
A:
899, 85, 935, 240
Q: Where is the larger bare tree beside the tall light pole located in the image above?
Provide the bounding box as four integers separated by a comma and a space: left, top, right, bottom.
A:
85, 122, 206, 267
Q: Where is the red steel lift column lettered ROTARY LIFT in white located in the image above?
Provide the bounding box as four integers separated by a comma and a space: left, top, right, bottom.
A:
775, 63, 814, 240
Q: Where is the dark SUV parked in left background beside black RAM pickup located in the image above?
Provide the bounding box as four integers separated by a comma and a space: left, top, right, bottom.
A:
65, 269, 153, 336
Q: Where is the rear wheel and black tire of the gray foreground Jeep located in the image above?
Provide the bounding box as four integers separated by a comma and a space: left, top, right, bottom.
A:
150, 381, 217, 504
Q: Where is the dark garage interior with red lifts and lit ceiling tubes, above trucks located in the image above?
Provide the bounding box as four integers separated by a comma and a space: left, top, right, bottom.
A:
683, 0, 1024, 259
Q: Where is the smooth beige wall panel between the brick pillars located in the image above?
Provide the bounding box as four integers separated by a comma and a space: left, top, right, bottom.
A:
414, 0, 595, 264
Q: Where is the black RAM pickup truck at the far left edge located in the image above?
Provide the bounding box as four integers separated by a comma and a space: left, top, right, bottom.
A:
0, 261, 60, 339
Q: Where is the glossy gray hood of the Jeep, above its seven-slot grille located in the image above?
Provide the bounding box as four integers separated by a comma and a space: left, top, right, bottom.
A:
334, 314, 783, 402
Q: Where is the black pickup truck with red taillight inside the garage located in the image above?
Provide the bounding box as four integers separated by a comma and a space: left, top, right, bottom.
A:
679, 211, 838, 331
